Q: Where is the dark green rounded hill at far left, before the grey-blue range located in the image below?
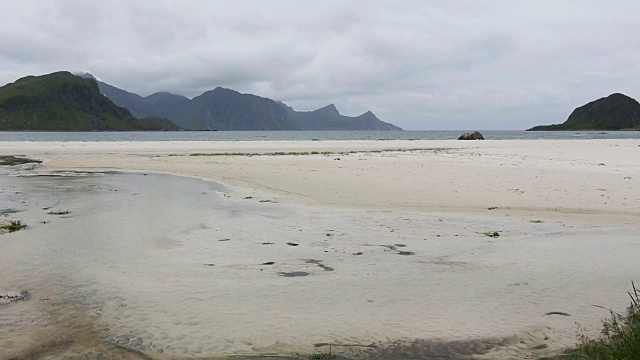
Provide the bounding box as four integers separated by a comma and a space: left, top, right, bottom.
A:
0, 72, 179, 131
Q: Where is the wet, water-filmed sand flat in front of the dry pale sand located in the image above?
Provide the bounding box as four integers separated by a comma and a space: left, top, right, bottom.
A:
0, 171, 640, 359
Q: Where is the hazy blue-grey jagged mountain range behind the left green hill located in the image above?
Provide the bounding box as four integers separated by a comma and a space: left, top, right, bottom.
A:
79, 74, 402, 130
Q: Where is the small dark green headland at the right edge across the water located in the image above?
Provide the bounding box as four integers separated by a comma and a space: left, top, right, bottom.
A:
528, 93, 640, 131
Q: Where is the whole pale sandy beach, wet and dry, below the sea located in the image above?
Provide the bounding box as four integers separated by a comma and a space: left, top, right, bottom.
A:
0, 140, 640, 359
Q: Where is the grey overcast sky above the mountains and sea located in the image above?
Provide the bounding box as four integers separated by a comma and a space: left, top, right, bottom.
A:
0, 0, 640, 130
